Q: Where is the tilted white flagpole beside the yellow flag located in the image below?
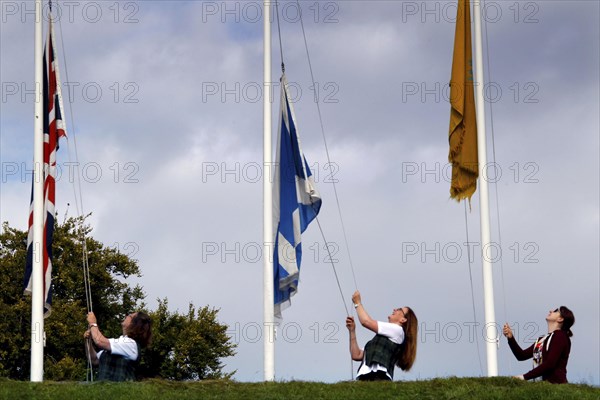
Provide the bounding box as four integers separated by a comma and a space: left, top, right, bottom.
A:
473, 1, 498, 376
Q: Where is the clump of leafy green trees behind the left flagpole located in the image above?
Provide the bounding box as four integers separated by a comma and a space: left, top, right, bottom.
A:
0, 217, 235, 380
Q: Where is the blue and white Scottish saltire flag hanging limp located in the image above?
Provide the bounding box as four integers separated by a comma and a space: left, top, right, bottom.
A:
273, 74, 321, 318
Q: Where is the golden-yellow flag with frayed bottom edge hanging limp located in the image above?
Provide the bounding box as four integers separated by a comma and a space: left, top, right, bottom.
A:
448, 0, 479, 202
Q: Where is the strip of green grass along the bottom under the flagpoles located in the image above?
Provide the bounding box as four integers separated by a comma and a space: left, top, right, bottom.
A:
0, 377, 600, 400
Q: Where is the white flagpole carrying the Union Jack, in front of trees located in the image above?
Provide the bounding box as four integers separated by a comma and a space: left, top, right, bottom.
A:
30, 0, 45, 382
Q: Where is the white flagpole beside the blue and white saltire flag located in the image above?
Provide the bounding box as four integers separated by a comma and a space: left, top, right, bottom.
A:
263, 0, 275, 381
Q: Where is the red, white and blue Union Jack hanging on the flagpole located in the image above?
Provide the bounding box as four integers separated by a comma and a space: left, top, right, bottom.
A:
24, 13, 66, 316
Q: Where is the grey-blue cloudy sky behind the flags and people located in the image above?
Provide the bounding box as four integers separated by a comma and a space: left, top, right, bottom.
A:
0, 0, 600, 385
